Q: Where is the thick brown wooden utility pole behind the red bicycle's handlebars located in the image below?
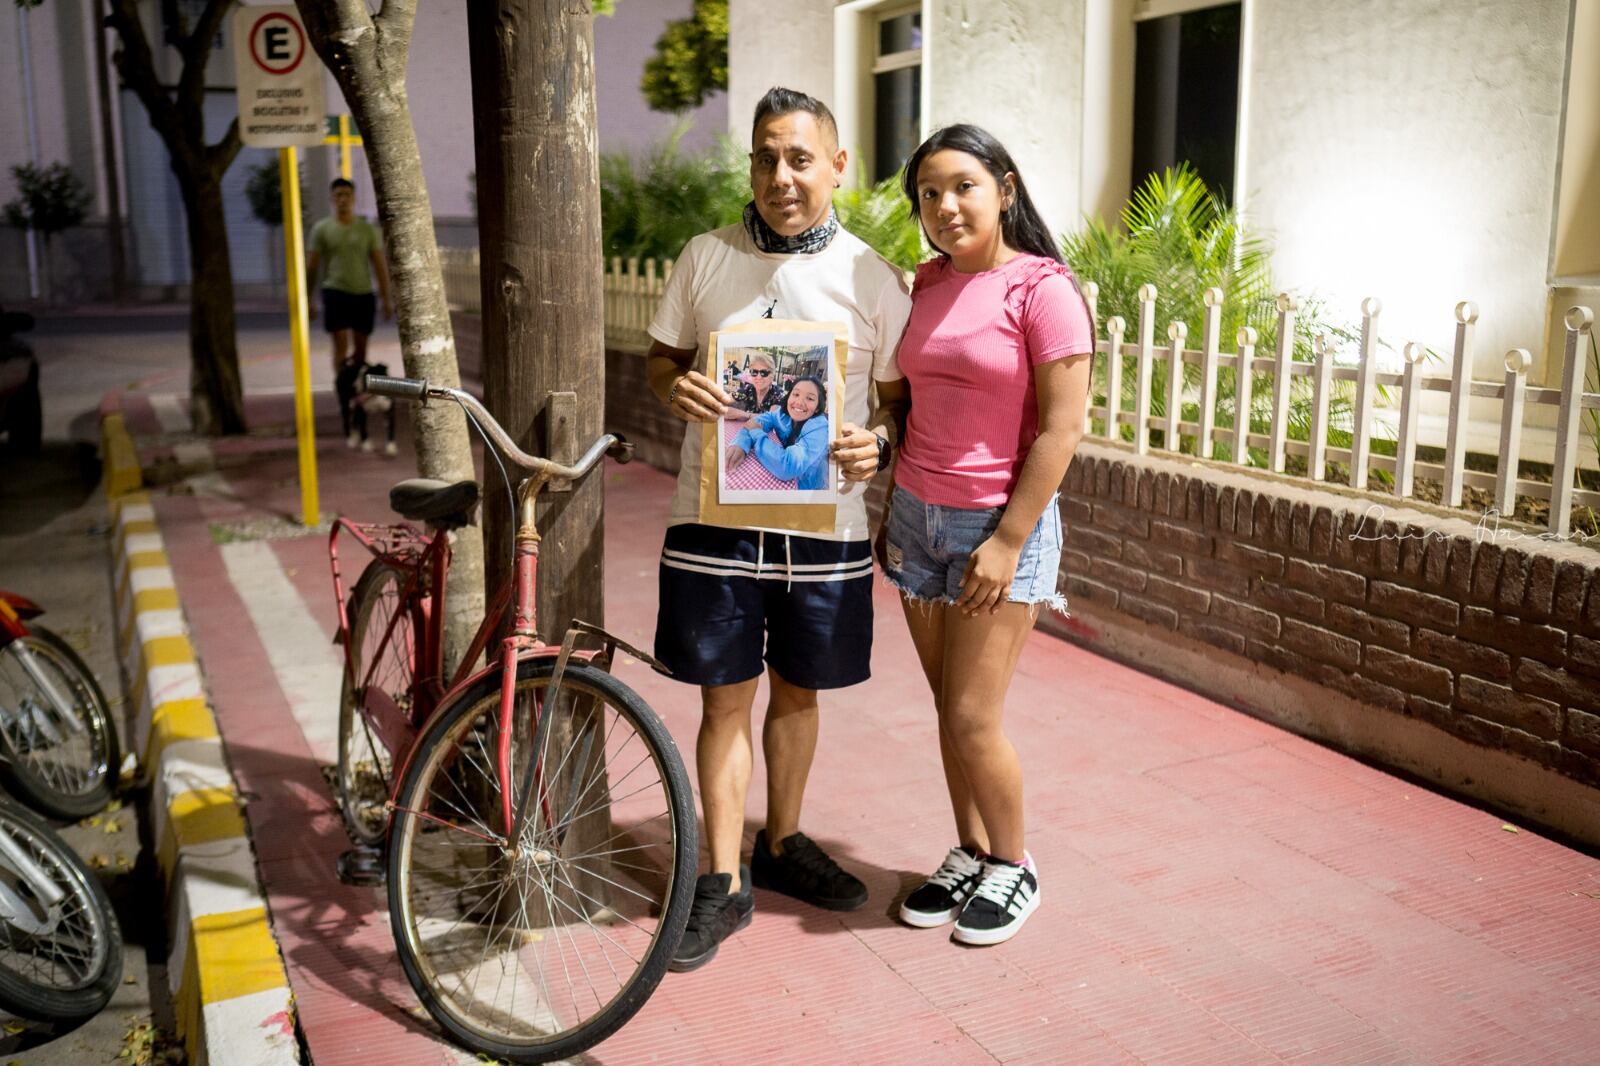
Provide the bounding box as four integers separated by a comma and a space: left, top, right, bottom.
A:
467, 0, 605, 640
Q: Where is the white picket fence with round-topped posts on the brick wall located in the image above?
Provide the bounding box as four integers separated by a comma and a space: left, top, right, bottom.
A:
440, 248, 1600, 536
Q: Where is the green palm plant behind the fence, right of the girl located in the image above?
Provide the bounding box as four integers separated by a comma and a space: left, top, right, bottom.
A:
1061, 163, 1355, 463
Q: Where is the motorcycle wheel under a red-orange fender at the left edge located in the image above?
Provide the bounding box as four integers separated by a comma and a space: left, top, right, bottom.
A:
0, 626, 122, 820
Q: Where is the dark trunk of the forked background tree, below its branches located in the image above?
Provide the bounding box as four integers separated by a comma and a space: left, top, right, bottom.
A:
182, 174, 245, 435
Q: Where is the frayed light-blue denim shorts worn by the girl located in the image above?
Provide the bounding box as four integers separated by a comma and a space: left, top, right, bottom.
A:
885, 488, 1067, 611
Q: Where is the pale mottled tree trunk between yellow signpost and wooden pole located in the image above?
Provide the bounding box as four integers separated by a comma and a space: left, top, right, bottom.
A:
296, 0, 480, 677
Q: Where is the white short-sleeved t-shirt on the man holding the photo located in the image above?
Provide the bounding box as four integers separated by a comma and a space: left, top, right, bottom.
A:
650, 222, 910, 541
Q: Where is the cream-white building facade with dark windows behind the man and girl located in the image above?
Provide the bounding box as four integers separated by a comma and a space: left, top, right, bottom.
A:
728, 0, 1600, 390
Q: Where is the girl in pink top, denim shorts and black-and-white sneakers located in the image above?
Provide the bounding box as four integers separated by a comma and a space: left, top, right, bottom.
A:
880, 125, 1094, 944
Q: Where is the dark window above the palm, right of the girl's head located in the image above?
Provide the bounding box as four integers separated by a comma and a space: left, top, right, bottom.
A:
1131, 3, 1240, 200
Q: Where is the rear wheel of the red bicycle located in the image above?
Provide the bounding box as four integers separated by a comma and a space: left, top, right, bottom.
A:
338, 559, 418, 845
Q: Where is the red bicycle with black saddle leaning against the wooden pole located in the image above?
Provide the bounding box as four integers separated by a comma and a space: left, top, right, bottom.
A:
328, 376, 699, 1063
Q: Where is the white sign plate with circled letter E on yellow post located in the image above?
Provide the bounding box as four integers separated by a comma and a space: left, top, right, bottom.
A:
232, 5, 326, 147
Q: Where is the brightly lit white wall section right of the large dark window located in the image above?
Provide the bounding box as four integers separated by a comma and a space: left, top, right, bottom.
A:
1240, 0, 1570, 379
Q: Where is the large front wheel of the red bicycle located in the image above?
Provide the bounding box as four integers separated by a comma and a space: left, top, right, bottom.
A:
389, 659, 699, 1063
